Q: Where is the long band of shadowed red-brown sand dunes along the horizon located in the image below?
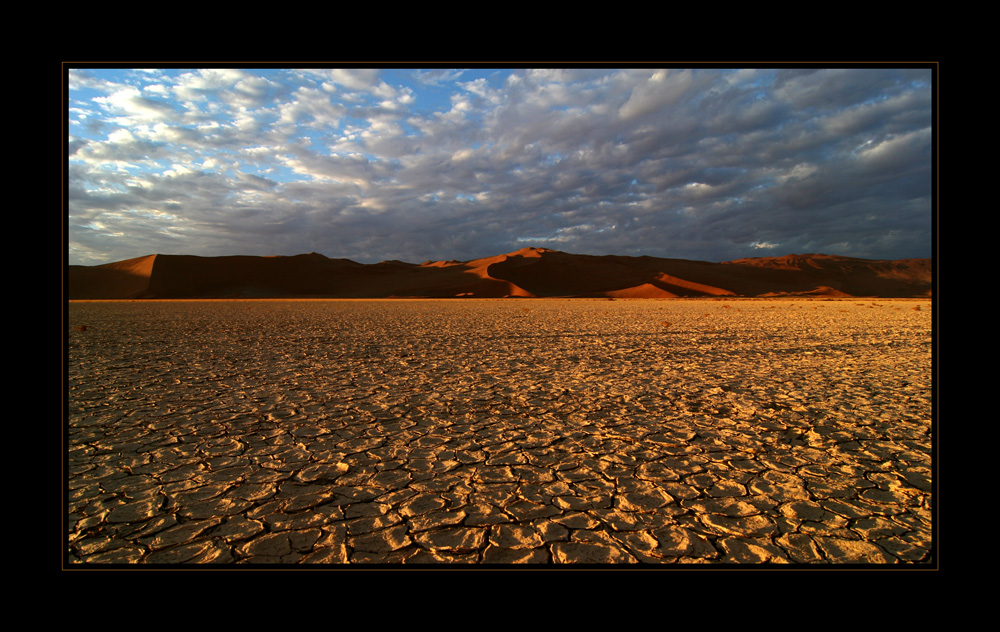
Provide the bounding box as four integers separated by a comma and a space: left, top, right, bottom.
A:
67, 248, 932, 299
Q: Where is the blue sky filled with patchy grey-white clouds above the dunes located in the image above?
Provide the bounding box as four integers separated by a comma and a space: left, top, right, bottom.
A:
66, 66, 934, 265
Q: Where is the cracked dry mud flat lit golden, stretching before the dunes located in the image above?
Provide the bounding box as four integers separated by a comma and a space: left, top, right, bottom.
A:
65, 299, 934, 567
